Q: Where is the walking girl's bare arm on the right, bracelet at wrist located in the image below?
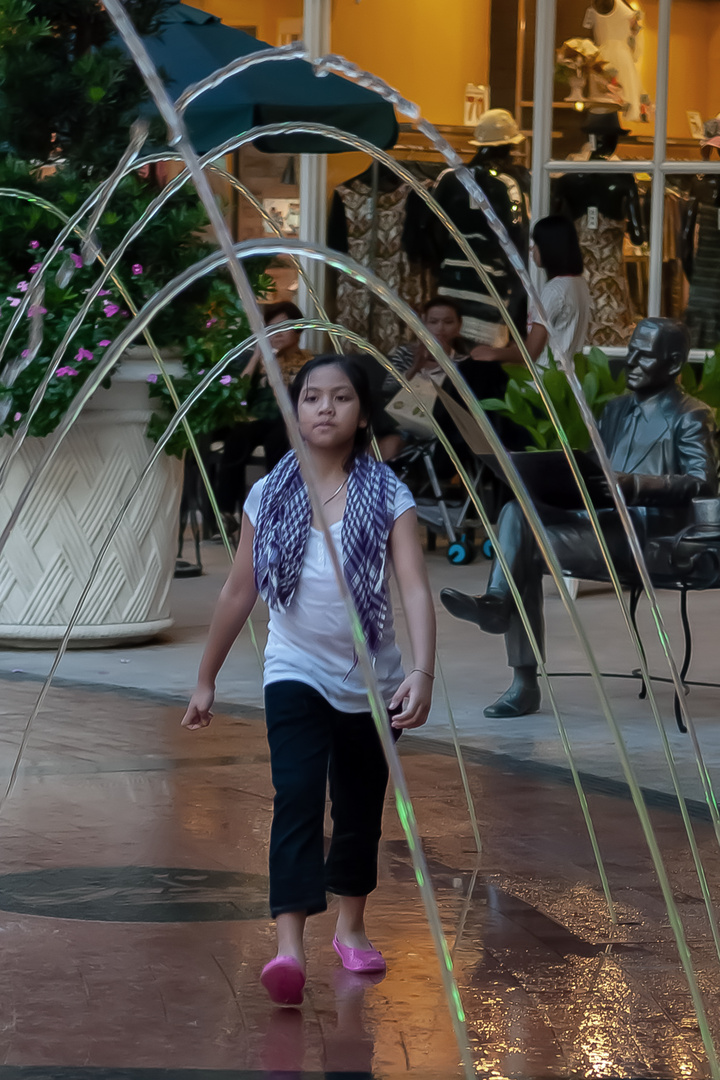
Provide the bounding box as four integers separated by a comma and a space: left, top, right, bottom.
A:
390, 510, 435, 728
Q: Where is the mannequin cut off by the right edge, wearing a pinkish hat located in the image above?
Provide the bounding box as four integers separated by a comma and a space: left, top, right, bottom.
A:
682, 132, 720, 349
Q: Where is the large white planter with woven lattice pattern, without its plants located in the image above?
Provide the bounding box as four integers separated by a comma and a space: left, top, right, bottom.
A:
0, 348, 182, 648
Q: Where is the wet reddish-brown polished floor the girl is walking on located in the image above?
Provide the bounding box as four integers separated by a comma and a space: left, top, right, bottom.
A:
0, 678, 720, 1080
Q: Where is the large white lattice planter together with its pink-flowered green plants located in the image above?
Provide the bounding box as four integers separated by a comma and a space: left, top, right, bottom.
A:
0, 0, 269, 645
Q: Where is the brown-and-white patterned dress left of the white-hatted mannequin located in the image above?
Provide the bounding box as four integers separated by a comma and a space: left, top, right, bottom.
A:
330, 178, 433, 354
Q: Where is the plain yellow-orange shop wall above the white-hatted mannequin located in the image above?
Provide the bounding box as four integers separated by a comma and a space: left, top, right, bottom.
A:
331, 0, 490, 124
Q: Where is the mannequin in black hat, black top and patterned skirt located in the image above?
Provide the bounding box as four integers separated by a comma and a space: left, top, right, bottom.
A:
553, 109, 646, 347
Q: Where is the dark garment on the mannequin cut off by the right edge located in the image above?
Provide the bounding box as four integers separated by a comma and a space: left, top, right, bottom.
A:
685, 203, 720, 349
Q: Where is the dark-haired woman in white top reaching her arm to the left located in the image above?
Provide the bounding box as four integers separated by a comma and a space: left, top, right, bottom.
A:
471, 215, 590, 375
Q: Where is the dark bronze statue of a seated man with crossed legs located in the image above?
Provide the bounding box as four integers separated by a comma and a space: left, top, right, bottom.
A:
440, 319, 718, 717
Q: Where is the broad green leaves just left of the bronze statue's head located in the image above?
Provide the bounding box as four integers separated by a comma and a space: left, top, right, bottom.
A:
480, 348, 625, 450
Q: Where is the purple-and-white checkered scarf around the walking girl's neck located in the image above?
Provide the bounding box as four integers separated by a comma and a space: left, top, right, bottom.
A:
253, 450, 397, 656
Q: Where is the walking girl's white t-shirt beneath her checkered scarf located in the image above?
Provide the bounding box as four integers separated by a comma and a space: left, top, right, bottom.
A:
243, 477, 415, 713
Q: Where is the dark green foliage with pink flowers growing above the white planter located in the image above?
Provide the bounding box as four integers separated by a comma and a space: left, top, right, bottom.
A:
0, 0, 272, 454
